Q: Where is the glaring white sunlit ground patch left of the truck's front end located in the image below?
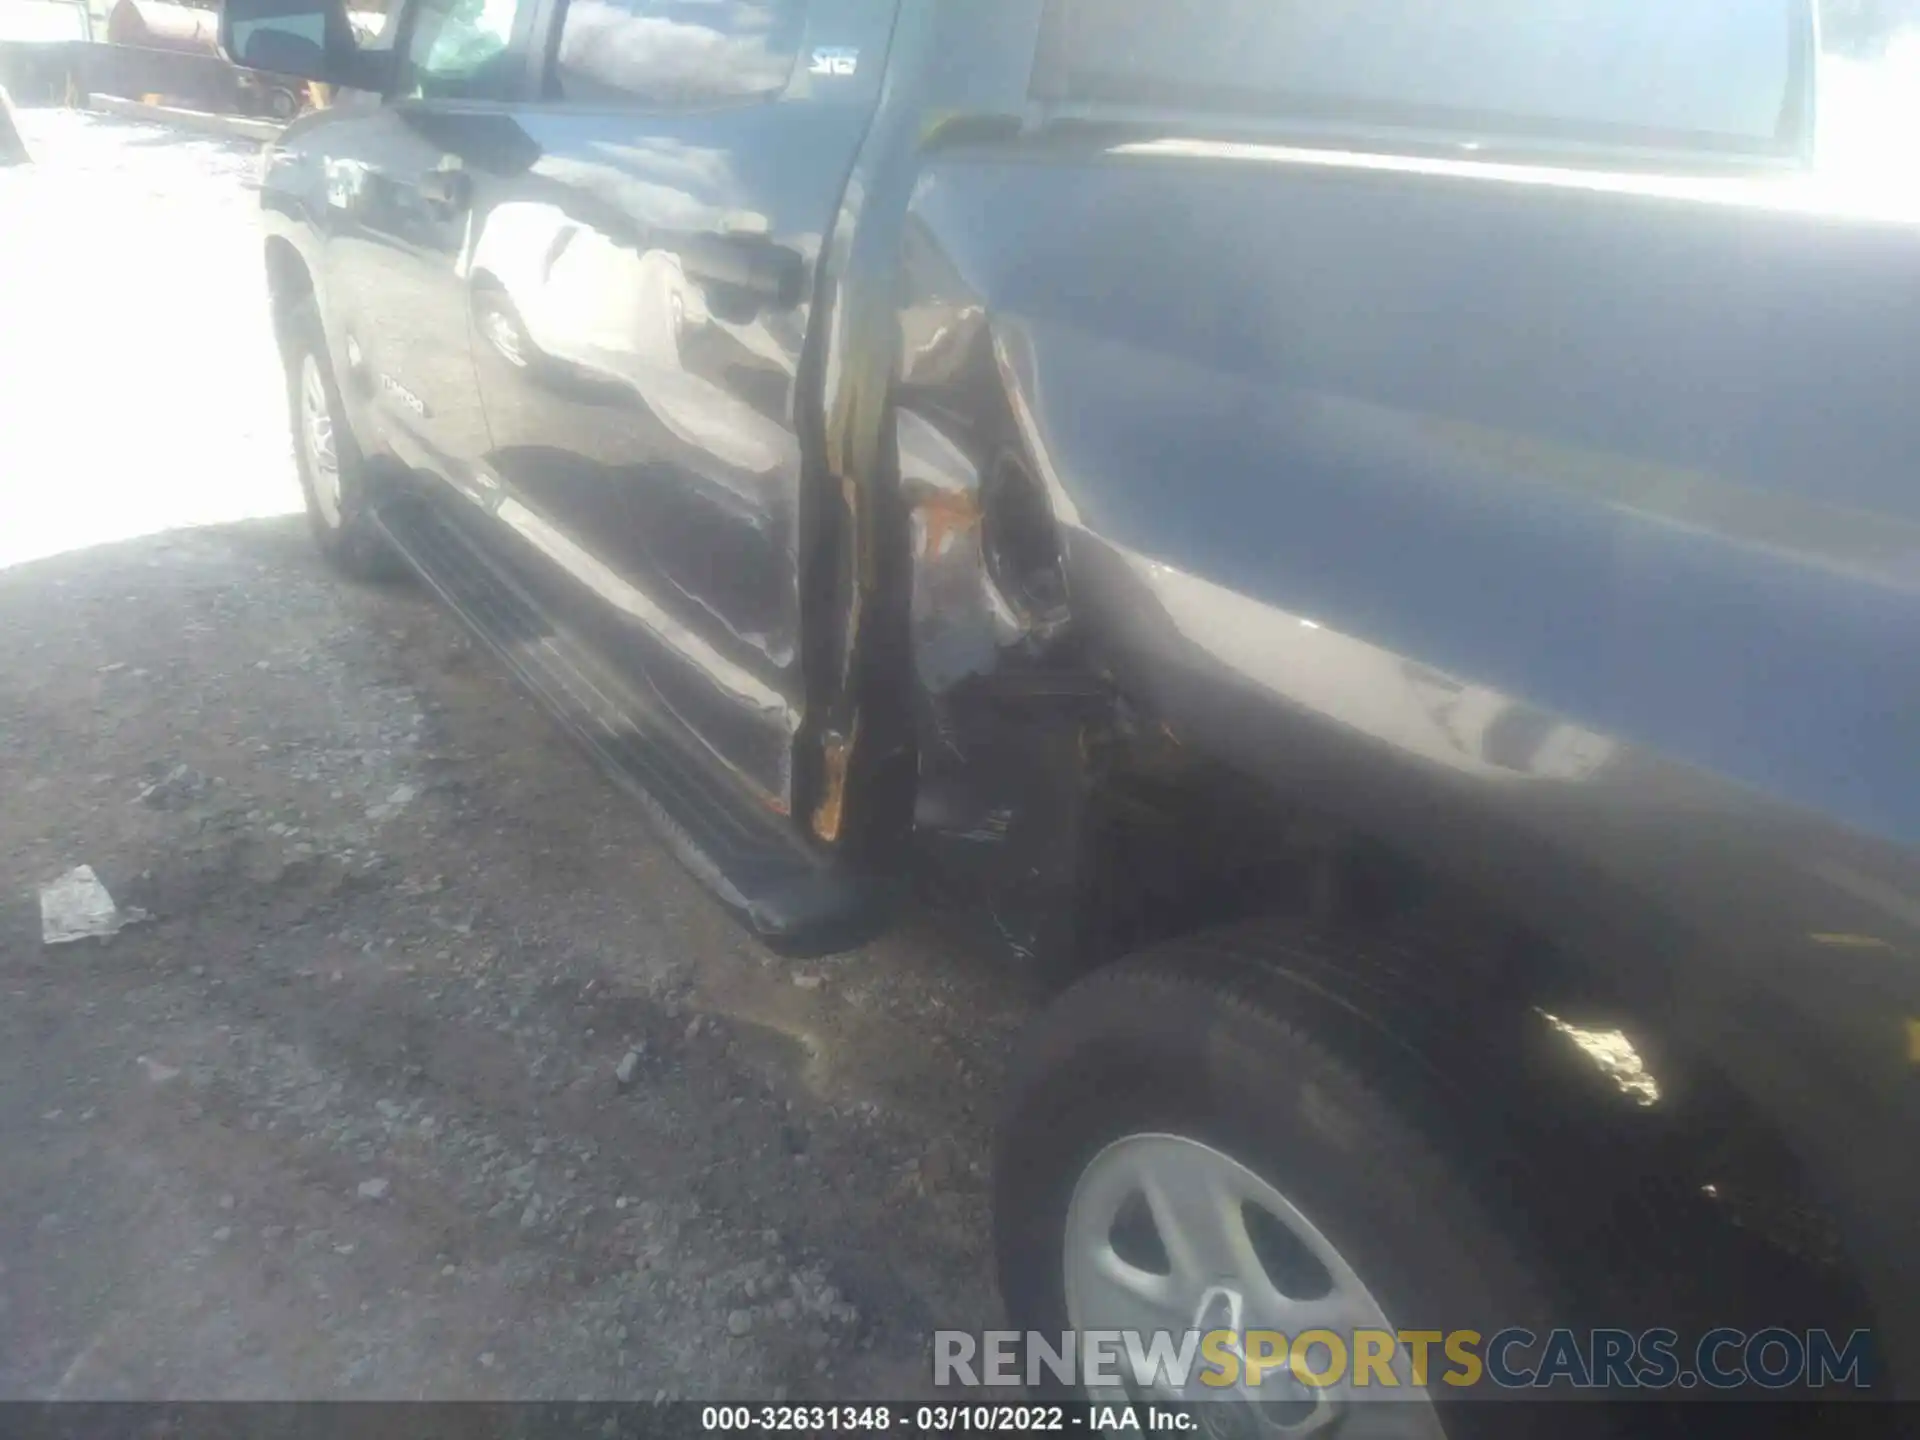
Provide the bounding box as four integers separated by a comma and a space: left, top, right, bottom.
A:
0, 109, 301, 572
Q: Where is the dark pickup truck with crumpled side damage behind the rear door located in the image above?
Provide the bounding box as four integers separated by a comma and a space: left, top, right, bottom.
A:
223, 0, 1920, 1436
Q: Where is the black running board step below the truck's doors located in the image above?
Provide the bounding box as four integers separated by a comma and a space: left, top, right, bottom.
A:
378, 497, 895, 954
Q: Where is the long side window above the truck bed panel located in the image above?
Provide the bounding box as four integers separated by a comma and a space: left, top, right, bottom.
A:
1035, 0, 1811, 154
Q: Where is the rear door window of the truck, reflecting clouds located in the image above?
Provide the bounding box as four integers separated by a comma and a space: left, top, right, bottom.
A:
549, 0, 806, 109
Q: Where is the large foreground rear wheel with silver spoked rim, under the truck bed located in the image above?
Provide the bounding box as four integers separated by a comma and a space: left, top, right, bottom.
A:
995, 931, 1551, 1440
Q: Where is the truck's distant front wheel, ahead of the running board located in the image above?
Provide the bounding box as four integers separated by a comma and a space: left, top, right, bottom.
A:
282, 300, 405, 580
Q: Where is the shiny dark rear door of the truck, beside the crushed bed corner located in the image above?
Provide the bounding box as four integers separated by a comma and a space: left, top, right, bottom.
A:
470, 0, 895, 812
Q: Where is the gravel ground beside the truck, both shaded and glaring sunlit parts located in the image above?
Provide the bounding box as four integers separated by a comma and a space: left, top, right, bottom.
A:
0, 111, 1033, 1400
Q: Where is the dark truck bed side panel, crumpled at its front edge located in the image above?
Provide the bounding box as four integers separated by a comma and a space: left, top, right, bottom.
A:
900, 140, 1920, 1390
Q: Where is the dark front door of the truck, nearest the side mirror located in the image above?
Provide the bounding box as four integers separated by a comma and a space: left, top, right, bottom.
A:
323, 0, 534, 488
